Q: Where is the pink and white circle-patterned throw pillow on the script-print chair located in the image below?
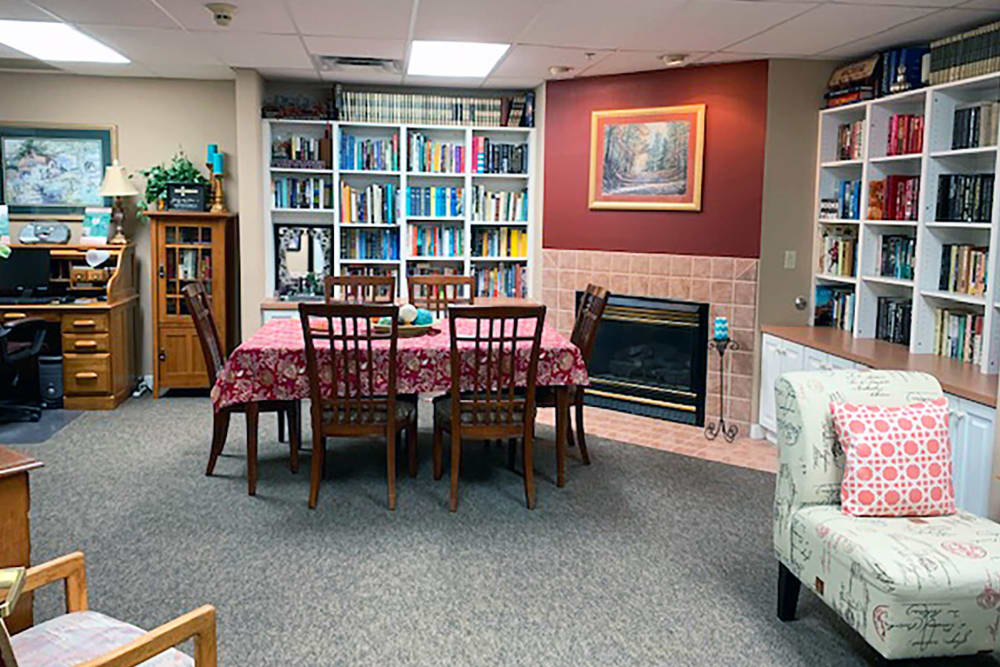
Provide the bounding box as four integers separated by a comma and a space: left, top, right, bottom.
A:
830, 397, 955, 516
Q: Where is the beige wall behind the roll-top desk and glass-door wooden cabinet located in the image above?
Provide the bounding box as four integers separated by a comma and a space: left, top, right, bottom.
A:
0, 73, 239, 375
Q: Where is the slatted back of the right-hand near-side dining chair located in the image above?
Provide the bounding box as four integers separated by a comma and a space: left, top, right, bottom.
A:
448, 306, 545, 428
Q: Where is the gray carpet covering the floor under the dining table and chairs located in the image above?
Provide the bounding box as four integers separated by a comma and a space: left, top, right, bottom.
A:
20, 398, 997, 667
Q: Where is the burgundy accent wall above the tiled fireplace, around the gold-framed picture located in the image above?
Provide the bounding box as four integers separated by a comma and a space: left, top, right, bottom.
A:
542, 61, 767, 258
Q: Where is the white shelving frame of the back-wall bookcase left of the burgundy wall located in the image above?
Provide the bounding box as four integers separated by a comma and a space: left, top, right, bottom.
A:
262, 119, 539, 296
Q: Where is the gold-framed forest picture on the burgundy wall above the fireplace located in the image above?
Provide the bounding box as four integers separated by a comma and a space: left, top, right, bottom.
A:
589, 104, 705, 211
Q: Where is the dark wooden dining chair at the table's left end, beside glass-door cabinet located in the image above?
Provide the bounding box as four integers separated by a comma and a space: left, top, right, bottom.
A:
183, 282, 302, 496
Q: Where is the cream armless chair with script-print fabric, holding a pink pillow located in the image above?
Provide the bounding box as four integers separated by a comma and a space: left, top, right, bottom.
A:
774, 371, 1000, 659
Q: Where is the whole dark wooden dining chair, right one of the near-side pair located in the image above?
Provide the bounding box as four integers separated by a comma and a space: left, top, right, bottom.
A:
434, 306, 545, 512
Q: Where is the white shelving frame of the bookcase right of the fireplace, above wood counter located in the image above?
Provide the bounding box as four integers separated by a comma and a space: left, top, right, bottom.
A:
810, 73, 1000, 373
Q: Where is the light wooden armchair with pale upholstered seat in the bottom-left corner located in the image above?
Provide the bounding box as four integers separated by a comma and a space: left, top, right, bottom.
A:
0, 551, 217, 667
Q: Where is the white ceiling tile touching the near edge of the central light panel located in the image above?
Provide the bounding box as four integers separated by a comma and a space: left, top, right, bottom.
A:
413, 0, 545, 44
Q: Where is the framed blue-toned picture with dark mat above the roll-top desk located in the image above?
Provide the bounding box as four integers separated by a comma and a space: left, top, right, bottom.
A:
0, 122, 118, 218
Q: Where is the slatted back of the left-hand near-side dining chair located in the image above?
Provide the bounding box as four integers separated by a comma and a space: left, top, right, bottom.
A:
299, 303, 399, 428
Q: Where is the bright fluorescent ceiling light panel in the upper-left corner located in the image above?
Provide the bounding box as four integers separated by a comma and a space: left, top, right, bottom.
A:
0, 21, 129, 63
